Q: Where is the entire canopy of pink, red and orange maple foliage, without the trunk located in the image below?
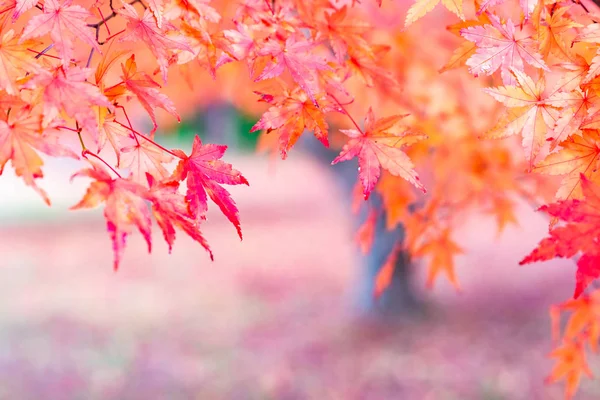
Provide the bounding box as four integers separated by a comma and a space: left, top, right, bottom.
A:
0, 0, 600, 397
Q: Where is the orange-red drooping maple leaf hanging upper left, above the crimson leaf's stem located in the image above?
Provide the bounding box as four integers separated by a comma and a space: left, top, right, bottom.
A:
105, 54, 181, 136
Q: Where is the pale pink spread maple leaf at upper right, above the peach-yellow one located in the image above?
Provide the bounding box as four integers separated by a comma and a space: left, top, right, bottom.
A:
460, 14, 550, 85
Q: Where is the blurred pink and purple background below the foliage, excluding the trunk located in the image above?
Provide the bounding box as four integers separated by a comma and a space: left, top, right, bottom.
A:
0, 107, 600, 400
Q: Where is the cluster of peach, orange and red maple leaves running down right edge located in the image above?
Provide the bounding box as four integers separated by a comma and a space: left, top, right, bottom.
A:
426, 0, 600, 397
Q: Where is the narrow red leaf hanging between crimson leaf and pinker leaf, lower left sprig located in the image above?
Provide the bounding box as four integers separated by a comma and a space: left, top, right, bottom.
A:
146, 174, 214, 260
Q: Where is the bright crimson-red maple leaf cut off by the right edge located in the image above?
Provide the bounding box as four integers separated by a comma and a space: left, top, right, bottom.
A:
520, 175, 600, 298
